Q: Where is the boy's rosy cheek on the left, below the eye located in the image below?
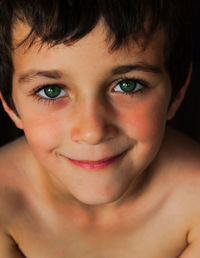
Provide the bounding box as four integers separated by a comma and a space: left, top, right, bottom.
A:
13, 91, 67, 152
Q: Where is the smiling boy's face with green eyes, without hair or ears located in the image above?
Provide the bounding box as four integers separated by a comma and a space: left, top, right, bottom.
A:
10, 20, 171, 204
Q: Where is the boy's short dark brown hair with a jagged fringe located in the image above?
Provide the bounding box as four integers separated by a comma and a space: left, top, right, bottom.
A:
0, 0, 192, 110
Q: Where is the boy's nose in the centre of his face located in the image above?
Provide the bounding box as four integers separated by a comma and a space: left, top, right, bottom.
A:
70, 99, 118, 145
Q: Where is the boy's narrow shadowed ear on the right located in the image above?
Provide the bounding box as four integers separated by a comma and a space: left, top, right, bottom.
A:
167, 65, 192, 120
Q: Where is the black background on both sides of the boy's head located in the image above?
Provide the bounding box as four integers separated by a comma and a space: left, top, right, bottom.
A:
0, 0, 200, 146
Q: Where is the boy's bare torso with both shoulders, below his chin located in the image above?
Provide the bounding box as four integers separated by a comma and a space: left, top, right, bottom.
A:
0, 128, 200, 258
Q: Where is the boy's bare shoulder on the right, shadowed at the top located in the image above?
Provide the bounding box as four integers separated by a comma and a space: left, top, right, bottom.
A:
161, 129, 200, 214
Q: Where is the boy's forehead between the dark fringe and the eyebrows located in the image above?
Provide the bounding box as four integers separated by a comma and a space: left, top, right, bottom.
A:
12, 22, 164, 76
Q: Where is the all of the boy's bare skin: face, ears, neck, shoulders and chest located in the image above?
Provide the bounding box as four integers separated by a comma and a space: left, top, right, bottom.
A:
0, 22, 200, 258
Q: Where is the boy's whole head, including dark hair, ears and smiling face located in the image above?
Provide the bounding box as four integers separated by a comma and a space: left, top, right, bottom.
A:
0, 0, 191, 204
